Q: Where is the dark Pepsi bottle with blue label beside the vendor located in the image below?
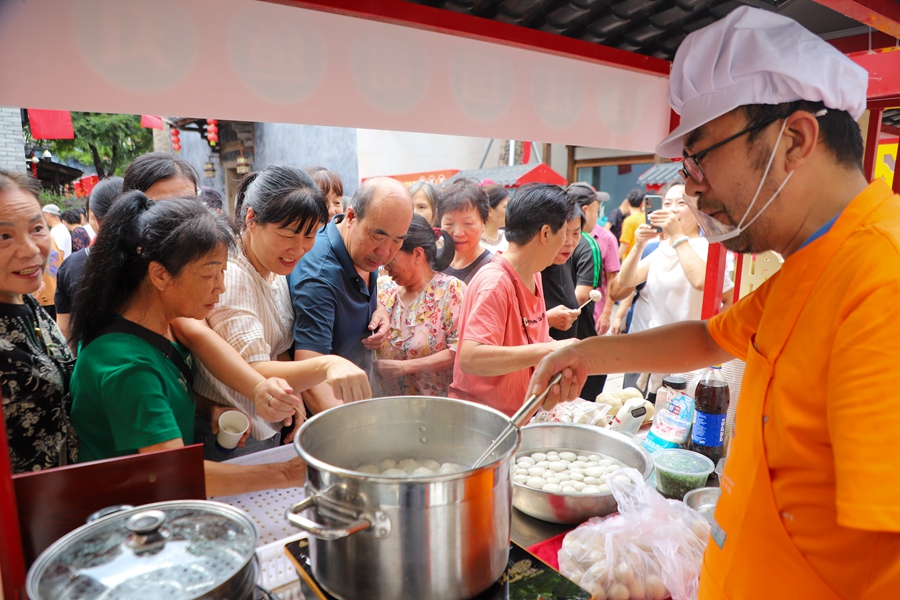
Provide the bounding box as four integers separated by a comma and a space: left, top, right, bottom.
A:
688, 365, 730, 464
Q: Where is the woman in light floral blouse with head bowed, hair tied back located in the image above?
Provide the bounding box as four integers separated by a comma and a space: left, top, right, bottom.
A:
375, 214, 466, 397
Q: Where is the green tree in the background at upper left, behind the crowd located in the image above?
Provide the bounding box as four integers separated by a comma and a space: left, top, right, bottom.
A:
28, 111, 153, 179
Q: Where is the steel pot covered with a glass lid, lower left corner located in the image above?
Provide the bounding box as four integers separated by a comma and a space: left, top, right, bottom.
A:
26, 500, 258, 600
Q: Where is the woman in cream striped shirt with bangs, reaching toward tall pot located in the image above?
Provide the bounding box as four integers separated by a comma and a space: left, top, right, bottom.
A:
194, 165, 372, 460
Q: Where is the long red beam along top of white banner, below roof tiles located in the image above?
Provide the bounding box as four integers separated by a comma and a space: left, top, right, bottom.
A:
266, 0, 672, 77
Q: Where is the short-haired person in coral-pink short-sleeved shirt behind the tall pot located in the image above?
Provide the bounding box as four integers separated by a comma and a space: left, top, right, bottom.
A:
450, 183, 575, 415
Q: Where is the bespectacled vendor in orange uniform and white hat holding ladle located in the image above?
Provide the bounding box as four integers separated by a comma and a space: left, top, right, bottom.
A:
532, 7, 900, 600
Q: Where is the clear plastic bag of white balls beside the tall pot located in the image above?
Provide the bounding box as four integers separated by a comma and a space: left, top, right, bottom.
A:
558, 469, 709, 600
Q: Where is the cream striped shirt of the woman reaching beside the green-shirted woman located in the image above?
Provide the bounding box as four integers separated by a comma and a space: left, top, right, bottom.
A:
194, 248, 294, 440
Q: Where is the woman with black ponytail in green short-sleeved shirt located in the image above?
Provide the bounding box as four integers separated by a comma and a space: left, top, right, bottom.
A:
71, 191, 305, 496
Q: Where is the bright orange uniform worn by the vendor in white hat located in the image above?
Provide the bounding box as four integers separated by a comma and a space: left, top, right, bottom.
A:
700, 180, 900, 600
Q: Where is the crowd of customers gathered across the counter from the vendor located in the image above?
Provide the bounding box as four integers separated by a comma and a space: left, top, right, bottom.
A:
0, 145, 716, 494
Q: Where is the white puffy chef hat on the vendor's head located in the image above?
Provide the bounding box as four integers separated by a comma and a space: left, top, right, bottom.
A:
656, 6, 869, 158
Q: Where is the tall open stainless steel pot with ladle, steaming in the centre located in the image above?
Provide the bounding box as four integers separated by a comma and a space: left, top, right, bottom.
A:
287, 396, 519, 600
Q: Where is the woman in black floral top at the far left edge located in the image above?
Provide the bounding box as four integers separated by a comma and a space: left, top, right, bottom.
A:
0, 170, 77, 473
